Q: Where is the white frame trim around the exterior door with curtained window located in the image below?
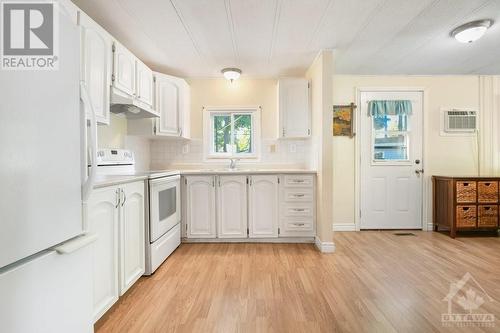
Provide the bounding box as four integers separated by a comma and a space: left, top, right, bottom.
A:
354, 87, 432, 231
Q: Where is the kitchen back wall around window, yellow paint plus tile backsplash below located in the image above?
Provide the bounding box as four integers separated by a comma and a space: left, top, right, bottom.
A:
151, 77, 311, 169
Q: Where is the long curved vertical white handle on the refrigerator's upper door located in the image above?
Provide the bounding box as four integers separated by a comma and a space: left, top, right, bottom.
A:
80, 81, 97, 203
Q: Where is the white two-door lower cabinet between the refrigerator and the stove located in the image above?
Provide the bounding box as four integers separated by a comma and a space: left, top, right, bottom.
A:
86, 182, 145, 322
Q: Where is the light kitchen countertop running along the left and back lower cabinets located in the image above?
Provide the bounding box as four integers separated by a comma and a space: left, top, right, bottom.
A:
94, 168, 317, 188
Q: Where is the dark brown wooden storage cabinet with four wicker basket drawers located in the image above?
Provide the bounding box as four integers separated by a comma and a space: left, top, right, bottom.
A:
432, 176, 500, 238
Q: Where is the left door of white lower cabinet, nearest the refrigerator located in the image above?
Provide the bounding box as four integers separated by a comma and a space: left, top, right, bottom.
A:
86, 187, 120, 322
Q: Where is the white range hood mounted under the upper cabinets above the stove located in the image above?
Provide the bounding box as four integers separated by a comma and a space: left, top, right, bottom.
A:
111, 87, 160, 119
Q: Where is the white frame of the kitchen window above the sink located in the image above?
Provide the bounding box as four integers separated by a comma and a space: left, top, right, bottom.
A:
203, 106, 261, 161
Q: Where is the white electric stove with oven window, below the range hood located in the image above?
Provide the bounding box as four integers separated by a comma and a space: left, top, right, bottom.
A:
97, 149, 181, 275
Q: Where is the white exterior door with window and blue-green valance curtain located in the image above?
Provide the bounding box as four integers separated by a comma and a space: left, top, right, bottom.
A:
359, 91, 423, 229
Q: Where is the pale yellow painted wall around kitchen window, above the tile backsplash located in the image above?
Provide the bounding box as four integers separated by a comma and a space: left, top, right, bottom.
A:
187, 78, 278, 139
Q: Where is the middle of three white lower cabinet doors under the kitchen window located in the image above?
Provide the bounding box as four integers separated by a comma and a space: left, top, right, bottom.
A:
217, 176, 248, 238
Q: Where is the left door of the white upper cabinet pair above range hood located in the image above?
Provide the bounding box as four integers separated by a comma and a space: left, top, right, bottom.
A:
113, 41, 136, 96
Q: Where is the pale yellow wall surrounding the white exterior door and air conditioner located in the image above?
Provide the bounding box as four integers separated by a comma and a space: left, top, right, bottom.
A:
333, 75, 480, 229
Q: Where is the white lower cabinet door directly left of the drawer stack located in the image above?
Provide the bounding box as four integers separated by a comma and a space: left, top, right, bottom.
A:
248, 175, 279, 238
